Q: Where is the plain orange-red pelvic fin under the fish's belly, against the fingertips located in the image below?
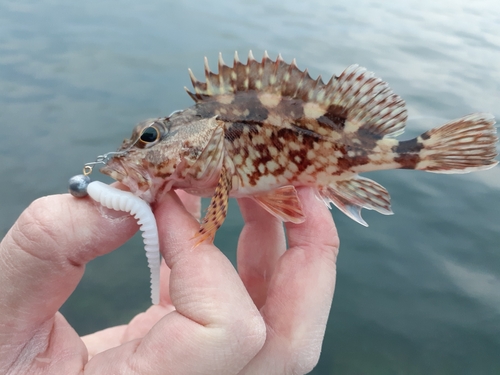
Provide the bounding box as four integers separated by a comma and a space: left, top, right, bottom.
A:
253, 185, 306, 224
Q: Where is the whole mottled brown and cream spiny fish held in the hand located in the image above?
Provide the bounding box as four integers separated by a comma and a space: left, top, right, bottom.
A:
101, 51, 498, 242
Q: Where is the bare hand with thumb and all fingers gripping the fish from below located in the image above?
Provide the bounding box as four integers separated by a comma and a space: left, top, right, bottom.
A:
0, 188, 339, 375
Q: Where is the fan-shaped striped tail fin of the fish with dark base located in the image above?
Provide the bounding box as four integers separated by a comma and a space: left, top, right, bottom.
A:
397, 113, 498, 173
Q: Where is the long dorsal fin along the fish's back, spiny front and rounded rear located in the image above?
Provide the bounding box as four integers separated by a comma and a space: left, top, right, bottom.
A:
186, 51, 407, 137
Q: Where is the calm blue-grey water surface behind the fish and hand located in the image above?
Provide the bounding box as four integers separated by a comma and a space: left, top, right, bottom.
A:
0, 0, 500, 374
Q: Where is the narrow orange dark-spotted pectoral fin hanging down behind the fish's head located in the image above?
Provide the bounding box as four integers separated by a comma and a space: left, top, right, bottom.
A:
195, 166, 231, 246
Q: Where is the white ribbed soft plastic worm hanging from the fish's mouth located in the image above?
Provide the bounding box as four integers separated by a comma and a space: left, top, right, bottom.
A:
87, 181, 161, 305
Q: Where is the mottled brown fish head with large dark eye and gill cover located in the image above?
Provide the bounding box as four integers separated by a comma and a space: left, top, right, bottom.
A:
101, 110, 220, 203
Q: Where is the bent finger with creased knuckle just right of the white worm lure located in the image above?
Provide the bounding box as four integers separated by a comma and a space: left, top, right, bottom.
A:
86, 191, 265, 375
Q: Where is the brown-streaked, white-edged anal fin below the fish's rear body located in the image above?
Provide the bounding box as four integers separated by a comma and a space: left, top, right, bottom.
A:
318, 176, 393, 226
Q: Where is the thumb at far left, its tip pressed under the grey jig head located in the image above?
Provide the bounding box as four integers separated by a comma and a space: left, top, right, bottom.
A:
0, 194, 138, 340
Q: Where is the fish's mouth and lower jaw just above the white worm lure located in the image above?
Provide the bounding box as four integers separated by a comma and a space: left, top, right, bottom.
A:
100, 157, 154, 203
